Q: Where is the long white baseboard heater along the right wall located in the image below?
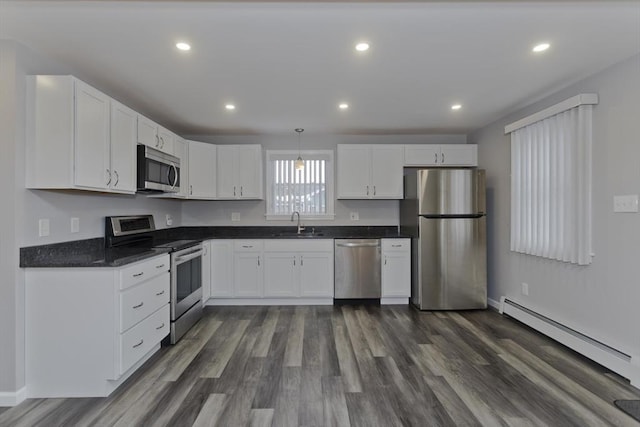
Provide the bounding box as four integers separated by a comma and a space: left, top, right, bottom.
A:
500, 296, 639, 387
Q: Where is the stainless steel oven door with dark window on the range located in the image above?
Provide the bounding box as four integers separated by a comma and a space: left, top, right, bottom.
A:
171, 245, 204, 321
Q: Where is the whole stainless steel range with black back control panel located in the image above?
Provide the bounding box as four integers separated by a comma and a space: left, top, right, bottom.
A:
105, 215, 204, 344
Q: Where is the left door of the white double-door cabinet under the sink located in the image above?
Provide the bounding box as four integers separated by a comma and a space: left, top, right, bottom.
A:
264, 252, 300, 298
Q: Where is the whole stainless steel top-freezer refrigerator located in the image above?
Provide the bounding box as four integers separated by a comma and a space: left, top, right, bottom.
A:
400, 169, 487, 310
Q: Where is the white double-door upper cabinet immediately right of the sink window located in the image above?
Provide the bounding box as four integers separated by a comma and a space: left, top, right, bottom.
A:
338, 144, 404, 199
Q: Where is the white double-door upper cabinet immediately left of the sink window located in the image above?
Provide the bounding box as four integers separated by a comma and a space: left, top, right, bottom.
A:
217, 144, 262, 199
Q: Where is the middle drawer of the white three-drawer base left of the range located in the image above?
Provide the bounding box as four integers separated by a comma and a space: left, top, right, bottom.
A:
120, 273, 170, 332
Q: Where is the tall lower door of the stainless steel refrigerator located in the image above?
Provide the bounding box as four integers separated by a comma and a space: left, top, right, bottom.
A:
412, 217, 487, 310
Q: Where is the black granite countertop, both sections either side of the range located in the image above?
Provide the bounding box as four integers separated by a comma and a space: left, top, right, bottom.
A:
20, 226, 408, 268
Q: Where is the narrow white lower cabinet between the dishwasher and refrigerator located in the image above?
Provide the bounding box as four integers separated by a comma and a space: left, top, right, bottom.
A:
381, 239, 411, 304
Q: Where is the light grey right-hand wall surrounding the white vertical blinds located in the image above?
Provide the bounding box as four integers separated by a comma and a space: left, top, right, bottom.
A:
469, 55, 640, 356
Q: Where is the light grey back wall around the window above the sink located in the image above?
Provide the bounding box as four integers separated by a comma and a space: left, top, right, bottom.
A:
182, 134, 467, 226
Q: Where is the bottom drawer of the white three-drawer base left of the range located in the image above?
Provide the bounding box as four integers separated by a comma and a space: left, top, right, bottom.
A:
120, 304, 169, 374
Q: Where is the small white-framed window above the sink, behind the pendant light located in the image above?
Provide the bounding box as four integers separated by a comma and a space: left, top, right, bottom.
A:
267, 150, 334, 220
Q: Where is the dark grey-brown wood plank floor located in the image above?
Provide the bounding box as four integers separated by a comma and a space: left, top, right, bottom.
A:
0, 306, 640, 427
